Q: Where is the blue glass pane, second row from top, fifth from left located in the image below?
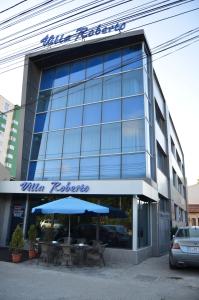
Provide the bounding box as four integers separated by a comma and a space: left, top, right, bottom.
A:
103, 75, 121, 100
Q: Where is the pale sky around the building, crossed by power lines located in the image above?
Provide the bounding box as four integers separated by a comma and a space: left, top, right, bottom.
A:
0, 0, 199, 185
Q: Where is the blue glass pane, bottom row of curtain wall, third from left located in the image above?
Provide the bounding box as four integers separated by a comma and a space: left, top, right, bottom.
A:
61, 159, 79, 180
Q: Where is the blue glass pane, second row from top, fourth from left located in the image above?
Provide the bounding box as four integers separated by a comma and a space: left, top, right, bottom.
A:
84, 78, 102, 103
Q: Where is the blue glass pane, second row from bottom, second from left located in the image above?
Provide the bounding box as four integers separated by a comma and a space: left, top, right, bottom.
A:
46, 130, 63, 158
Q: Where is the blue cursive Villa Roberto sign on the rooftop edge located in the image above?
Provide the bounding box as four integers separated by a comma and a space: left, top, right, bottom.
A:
40, 23, 126, 47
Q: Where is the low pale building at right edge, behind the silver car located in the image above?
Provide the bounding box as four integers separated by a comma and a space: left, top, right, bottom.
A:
188, 183, 199, 226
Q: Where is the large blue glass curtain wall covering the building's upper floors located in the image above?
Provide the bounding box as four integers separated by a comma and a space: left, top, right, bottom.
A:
28, 44, 150, 180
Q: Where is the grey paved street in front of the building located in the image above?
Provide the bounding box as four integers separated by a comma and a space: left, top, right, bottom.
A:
0, 255, 199, 300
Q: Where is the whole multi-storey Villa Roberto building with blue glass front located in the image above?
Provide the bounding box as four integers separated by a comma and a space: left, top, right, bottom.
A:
0, 30, 186, 263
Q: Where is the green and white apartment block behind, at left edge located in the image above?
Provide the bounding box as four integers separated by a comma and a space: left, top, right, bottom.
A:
0, 96, 20, 178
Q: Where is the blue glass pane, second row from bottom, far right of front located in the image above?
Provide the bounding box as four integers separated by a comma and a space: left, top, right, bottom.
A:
122, 120, 145, 152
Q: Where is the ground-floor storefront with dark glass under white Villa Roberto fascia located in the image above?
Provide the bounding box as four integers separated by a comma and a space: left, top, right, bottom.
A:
0, 181, 171, 263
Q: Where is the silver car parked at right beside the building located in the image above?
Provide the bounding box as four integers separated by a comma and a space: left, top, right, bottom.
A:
169, 226, 199, 269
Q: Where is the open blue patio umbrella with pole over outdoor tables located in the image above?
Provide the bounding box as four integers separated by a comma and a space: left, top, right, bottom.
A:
32, 197, 109, 241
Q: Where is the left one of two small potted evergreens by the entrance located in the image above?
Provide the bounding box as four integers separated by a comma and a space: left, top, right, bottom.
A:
10, 225, 24, 263
